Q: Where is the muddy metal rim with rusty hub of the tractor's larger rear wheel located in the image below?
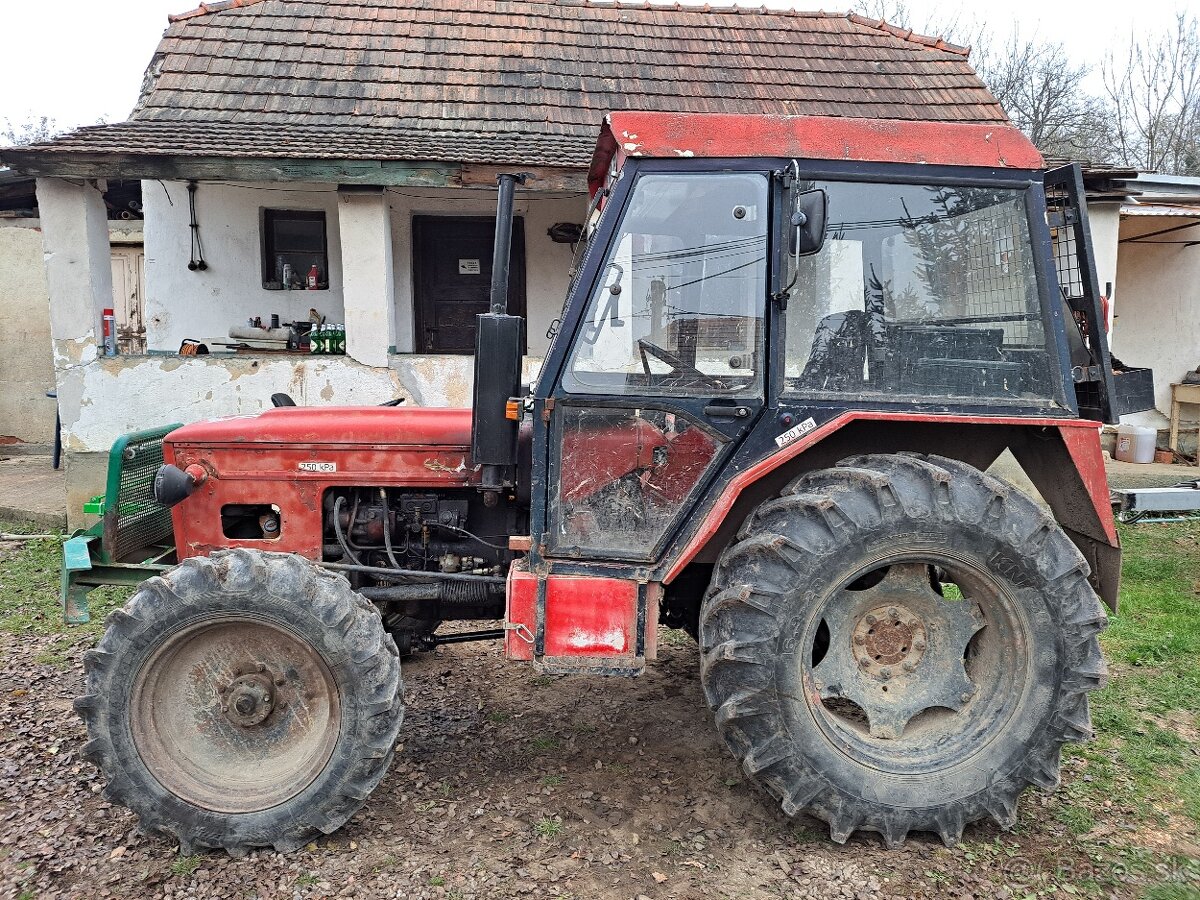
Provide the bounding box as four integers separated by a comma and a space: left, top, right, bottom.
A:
800, 553, 1032, 775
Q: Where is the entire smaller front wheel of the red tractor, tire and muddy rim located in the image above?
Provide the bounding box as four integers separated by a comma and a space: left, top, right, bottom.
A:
76, 550, 403, 856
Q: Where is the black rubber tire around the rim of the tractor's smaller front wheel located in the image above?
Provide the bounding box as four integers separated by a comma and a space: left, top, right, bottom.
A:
74, 550, 404, 856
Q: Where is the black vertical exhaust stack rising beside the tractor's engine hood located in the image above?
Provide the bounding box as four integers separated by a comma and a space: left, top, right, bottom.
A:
470, 174, 526, 491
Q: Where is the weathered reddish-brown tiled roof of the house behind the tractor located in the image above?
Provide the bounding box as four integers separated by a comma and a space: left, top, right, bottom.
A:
9, 0, 1007, 167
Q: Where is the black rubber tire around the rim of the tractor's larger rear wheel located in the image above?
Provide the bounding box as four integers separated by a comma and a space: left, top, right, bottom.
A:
701, 454, 1106, 847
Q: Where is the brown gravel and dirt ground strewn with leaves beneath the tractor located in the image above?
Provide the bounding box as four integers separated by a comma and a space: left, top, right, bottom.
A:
0, 631, 1132, 900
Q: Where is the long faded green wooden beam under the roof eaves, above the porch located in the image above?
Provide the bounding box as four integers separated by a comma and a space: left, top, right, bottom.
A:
4, 150, 462, 187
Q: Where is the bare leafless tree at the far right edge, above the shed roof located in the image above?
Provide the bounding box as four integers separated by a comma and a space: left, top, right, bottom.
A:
1102, 12, 1200, 175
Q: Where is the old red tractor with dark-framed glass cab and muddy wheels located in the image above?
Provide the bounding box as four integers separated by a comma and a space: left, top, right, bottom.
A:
77, 113, 1136, 854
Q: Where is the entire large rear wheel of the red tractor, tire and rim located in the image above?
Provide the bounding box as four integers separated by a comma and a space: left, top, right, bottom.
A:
701, 455, 1106, 847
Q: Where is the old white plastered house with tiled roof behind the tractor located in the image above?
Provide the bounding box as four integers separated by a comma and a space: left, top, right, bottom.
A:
0, 0, 1007, 521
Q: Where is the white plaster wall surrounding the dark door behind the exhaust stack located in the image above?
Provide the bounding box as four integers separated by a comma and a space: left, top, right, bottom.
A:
388, 187, 587, 359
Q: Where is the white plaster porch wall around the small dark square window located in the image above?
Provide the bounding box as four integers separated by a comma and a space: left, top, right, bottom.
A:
142, 181, 344, 353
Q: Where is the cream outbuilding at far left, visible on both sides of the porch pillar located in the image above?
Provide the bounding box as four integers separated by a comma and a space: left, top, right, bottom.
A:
0, 169, 144, 449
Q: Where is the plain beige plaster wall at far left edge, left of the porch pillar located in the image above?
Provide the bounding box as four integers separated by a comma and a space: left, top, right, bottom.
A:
0, 218, 54, 444
